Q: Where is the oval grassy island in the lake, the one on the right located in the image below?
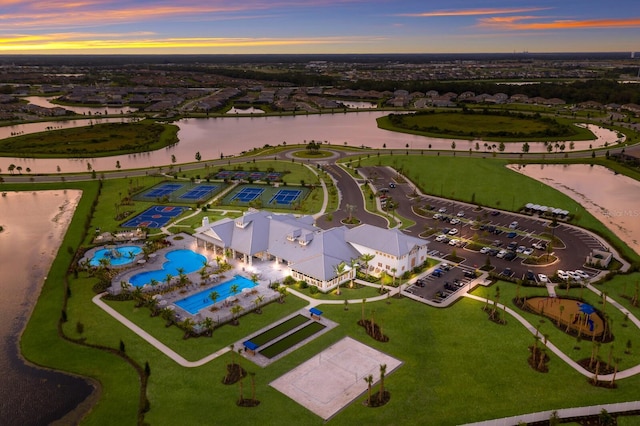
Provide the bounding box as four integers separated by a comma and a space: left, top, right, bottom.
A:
377, 109, 595, 142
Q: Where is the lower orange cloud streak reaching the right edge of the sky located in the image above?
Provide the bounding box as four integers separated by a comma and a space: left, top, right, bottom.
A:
478, 16, 640, 31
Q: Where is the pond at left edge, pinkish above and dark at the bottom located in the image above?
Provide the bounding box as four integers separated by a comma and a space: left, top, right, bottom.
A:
0, 191, 93, 425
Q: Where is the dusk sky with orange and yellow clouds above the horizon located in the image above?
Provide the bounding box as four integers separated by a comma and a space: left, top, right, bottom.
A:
0, 0, 640, 54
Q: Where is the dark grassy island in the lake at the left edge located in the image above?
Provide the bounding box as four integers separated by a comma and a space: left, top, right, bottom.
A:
0, 120, 178, 158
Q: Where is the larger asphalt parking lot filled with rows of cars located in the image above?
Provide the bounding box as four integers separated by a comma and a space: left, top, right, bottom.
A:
363, 167, 606, 282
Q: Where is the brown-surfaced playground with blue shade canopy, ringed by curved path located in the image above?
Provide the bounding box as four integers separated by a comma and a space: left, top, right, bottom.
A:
525, 297, 604, 337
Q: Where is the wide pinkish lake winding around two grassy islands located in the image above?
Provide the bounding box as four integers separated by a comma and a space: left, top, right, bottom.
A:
0, 111, 618, 173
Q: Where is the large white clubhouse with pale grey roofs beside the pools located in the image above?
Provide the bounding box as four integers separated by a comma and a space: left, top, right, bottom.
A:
194, 210, 428, 292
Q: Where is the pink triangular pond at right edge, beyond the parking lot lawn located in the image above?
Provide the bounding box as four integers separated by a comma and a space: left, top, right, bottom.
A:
511, 164, 640, 254
